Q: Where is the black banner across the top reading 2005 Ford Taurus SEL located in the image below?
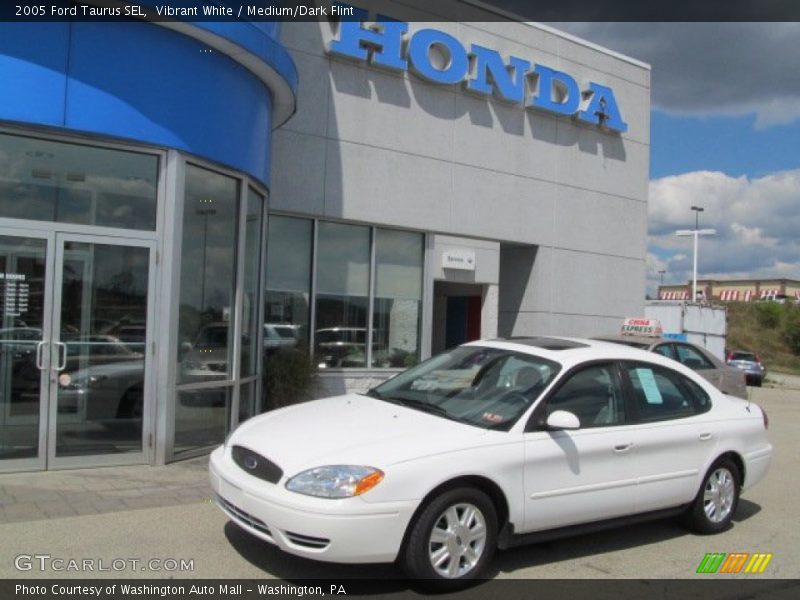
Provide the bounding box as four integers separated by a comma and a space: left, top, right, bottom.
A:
0, 0, 800, 22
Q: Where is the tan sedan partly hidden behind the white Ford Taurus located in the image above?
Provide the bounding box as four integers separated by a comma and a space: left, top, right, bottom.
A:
595, 335, 747, 399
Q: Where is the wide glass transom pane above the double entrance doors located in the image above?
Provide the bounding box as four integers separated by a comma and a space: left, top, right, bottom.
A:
0, 134, 158, 231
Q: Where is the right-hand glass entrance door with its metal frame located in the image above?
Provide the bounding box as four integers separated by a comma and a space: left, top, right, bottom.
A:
48, 234, 153, 467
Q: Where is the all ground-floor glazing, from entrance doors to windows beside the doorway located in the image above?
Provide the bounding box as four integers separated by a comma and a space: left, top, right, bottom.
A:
0, 133, 432, 471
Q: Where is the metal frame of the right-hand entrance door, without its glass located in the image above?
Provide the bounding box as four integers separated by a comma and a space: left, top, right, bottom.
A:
46, 232, 158, 469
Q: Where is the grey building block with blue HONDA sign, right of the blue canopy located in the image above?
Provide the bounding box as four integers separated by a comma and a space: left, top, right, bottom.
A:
266, 3, 650, 401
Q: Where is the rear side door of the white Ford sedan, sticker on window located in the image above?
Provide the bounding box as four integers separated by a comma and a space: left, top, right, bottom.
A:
622, 361, 719, 512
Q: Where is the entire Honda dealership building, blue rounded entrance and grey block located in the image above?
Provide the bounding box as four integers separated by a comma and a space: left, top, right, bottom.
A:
0, 3, 650, 472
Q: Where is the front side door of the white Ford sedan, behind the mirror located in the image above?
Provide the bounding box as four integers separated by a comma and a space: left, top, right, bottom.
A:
523, 362, 636, 531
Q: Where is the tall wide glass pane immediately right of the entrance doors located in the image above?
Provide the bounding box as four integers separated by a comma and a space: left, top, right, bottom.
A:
175, 164, 240, 453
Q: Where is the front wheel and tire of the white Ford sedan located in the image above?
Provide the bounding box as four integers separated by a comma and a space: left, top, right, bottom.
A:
399, 488, 497, 591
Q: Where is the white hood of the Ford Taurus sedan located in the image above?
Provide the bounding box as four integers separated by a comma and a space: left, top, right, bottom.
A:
229, 394, 490, 477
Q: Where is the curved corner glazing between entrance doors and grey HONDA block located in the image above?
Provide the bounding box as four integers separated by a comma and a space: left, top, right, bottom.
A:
175, 165, 265, 454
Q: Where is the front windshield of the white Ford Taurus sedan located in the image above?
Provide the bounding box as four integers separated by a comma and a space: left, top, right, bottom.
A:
367, 346, 560, 431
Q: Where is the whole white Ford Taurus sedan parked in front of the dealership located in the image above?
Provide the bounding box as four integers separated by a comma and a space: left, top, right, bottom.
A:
210, 338, 772, 588
